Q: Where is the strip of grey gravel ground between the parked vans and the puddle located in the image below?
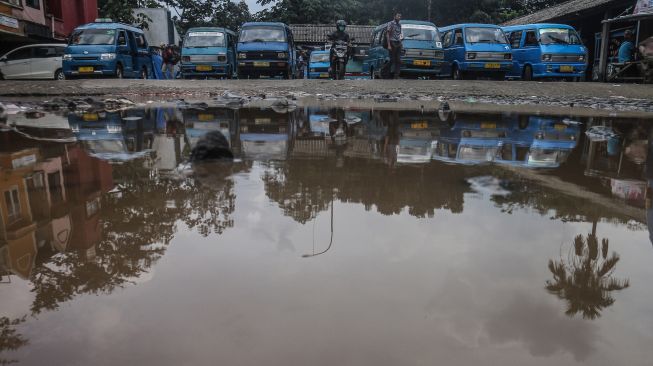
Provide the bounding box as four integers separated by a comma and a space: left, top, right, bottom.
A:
0, 79, 653, 117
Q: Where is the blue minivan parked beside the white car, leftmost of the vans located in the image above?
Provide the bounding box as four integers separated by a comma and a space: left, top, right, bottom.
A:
63, 19, 152, 79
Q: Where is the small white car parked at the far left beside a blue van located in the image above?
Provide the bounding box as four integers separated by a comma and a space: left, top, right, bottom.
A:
0, 43, 66, 80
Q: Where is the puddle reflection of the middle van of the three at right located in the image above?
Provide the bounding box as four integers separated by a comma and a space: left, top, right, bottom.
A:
433, 115, 510, 165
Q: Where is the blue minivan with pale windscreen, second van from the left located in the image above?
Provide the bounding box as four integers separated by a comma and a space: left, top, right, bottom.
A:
181, 27, 236, 79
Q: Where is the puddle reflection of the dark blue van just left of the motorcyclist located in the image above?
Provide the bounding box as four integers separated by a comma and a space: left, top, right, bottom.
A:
238, 108, 290, 160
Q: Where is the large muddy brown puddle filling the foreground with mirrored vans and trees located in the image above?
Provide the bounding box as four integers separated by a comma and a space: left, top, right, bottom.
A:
0, 98, 653, 365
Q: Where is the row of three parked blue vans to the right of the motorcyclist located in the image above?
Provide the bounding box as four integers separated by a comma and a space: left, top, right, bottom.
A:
366, 21, 587, 80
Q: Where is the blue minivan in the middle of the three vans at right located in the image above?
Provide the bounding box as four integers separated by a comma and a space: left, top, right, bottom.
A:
440, 24, 512, 80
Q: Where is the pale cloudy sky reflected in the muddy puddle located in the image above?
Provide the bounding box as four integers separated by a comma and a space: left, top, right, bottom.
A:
3, 166, 653, 366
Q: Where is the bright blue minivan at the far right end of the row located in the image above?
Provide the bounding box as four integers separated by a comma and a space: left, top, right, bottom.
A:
503, 24, 587, 81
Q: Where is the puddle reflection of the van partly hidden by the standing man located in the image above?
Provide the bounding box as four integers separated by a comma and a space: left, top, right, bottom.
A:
397, 111, 440, 163
